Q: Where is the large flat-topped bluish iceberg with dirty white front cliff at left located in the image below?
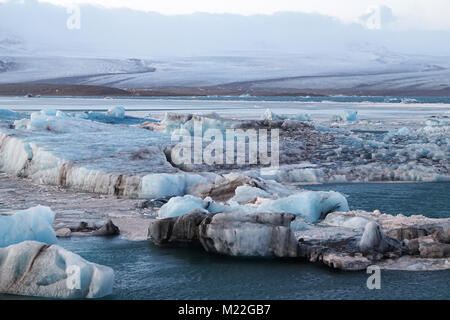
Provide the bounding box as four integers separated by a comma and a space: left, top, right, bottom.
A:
0, 110, 178, 197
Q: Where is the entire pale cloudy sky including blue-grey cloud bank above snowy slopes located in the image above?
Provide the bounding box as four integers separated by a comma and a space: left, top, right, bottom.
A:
0, 0, 450, 59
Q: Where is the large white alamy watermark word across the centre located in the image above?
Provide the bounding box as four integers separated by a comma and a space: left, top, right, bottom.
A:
171, 120, 280, 168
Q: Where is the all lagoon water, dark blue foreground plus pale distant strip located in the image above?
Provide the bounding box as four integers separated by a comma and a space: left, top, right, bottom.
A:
0, 97, 450, 299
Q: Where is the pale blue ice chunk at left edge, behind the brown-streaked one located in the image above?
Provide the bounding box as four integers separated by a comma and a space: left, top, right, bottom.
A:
0, 206, 57, 247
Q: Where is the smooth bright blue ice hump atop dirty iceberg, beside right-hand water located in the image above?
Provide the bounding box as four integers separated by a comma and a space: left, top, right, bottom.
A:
257, 191, 349, 223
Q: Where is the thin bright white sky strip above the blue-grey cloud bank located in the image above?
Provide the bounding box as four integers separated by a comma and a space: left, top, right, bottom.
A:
28, 0, 450, 30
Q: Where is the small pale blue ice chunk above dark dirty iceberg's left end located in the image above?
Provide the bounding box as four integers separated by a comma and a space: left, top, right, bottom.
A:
158, 195, 209, 219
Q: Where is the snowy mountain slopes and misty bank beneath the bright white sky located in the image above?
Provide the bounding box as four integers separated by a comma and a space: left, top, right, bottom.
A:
0, 0, 450, 92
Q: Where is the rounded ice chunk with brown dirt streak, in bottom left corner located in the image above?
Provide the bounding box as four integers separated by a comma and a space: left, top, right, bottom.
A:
0, 241, 114, 299
